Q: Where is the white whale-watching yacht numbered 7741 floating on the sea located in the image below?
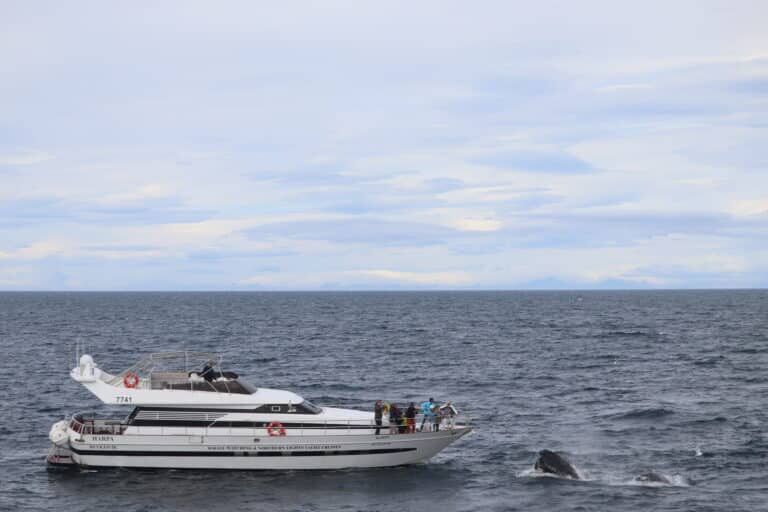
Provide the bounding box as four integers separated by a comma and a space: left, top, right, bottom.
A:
47, 352, 472, 469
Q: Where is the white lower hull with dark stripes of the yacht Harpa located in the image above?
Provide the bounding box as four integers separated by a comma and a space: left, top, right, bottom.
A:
70, 427, 471, 470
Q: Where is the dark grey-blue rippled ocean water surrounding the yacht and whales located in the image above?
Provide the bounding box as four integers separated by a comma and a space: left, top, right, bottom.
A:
0, 291, 768, 512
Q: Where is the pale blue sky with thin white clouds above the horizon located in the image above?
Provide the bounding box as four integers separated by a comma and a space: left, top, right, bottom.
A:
0, 0, 768, 290
